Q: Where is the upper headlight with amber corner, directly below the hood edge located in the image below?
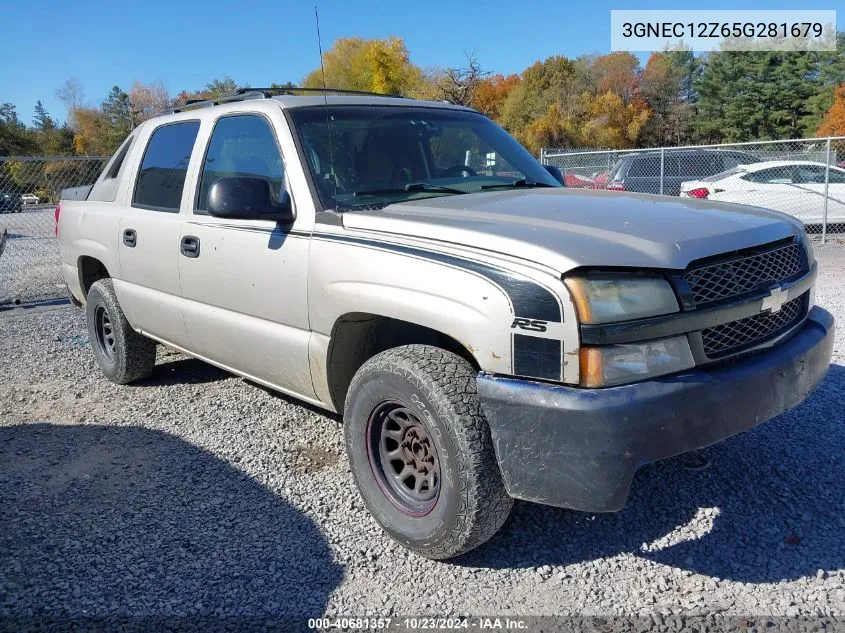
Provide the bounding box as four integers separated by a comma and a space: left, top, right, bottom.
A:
564, 275, 678, 324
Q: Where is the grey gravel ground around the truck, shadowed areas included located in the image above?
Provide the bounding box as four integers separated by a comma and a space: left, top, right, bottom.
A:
0, 245, 845, 617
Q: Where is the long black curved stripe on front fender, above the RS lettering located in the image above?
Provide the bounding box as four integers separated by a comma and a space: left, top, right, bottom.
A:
314, 233, 562, 323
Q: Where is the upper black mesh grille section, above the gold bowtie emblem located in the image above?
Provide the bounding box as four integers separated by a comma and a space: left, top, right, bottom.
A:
684, 243, 804, 307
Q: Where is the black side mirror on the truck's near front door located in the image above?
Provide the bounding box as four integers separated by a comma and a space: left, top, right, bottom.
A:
208, 176, 296, 224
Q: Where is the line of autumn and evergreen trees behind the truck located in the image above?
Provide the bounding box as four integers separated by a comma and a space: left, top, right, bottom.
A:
0, 33, 845, 163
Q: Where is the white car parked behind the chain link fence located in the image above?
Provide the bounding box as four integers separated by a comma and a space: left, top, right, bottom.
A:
681, 160, 845, 224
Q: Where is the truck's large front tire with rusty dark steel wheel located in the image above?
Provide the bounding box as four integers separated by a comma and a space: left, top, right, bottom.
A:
343, 345, 513, 559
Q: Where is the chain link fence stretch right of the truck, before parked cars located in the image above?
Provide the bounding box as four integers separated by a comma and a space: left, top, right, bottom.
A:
540, 136, 845, 241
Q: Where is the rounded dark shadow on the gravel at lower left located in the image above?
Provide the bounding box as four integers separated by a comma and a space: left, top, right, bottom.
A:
0, 424, 342, 630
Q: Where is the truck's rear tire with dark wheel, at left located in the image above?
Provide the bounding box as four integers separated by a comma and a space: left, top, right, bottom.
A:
85, 279, 156, 385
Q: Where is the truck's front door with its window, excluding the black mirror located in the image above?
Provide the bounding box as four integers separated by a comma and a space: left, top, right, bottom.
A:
179, 108, 314, 398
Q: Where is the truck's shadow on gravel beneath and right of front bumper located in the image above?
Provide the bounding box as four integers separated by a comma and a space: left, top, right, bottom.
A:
457, 365, 845, 583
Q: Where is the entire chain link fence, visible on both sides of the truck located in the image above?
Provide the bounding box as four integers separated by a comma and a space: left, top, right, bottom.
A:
0, 136, 845, 308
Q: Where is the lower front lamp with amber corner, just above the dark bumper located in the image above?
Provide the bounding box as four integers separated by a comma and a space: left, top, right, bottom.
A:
580, 336, 695, 387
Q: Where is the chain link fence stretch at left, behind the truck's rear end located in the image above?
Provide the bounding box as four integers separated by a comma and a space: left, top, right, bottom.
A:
0, 156, 108, 308
